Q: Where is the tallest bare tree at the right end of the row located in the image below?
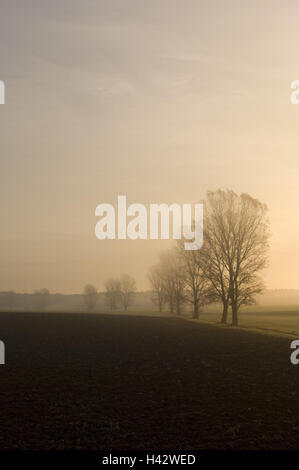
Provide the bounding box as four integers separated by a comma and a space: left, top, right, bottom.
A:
207, 190, 270, 325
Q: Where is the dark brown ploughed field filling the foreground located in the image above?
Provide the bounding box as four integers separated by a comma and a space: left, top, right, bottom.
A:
0, 313, 299, 450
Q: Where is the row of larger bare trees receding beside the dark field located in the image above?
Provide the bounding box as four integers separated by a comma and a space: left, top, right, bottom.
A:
148, 190, 270, 325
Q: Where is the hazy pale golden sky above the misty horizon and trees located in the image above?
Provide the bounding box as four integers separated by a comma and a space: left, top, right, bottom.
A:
0, 0, 299, 293
